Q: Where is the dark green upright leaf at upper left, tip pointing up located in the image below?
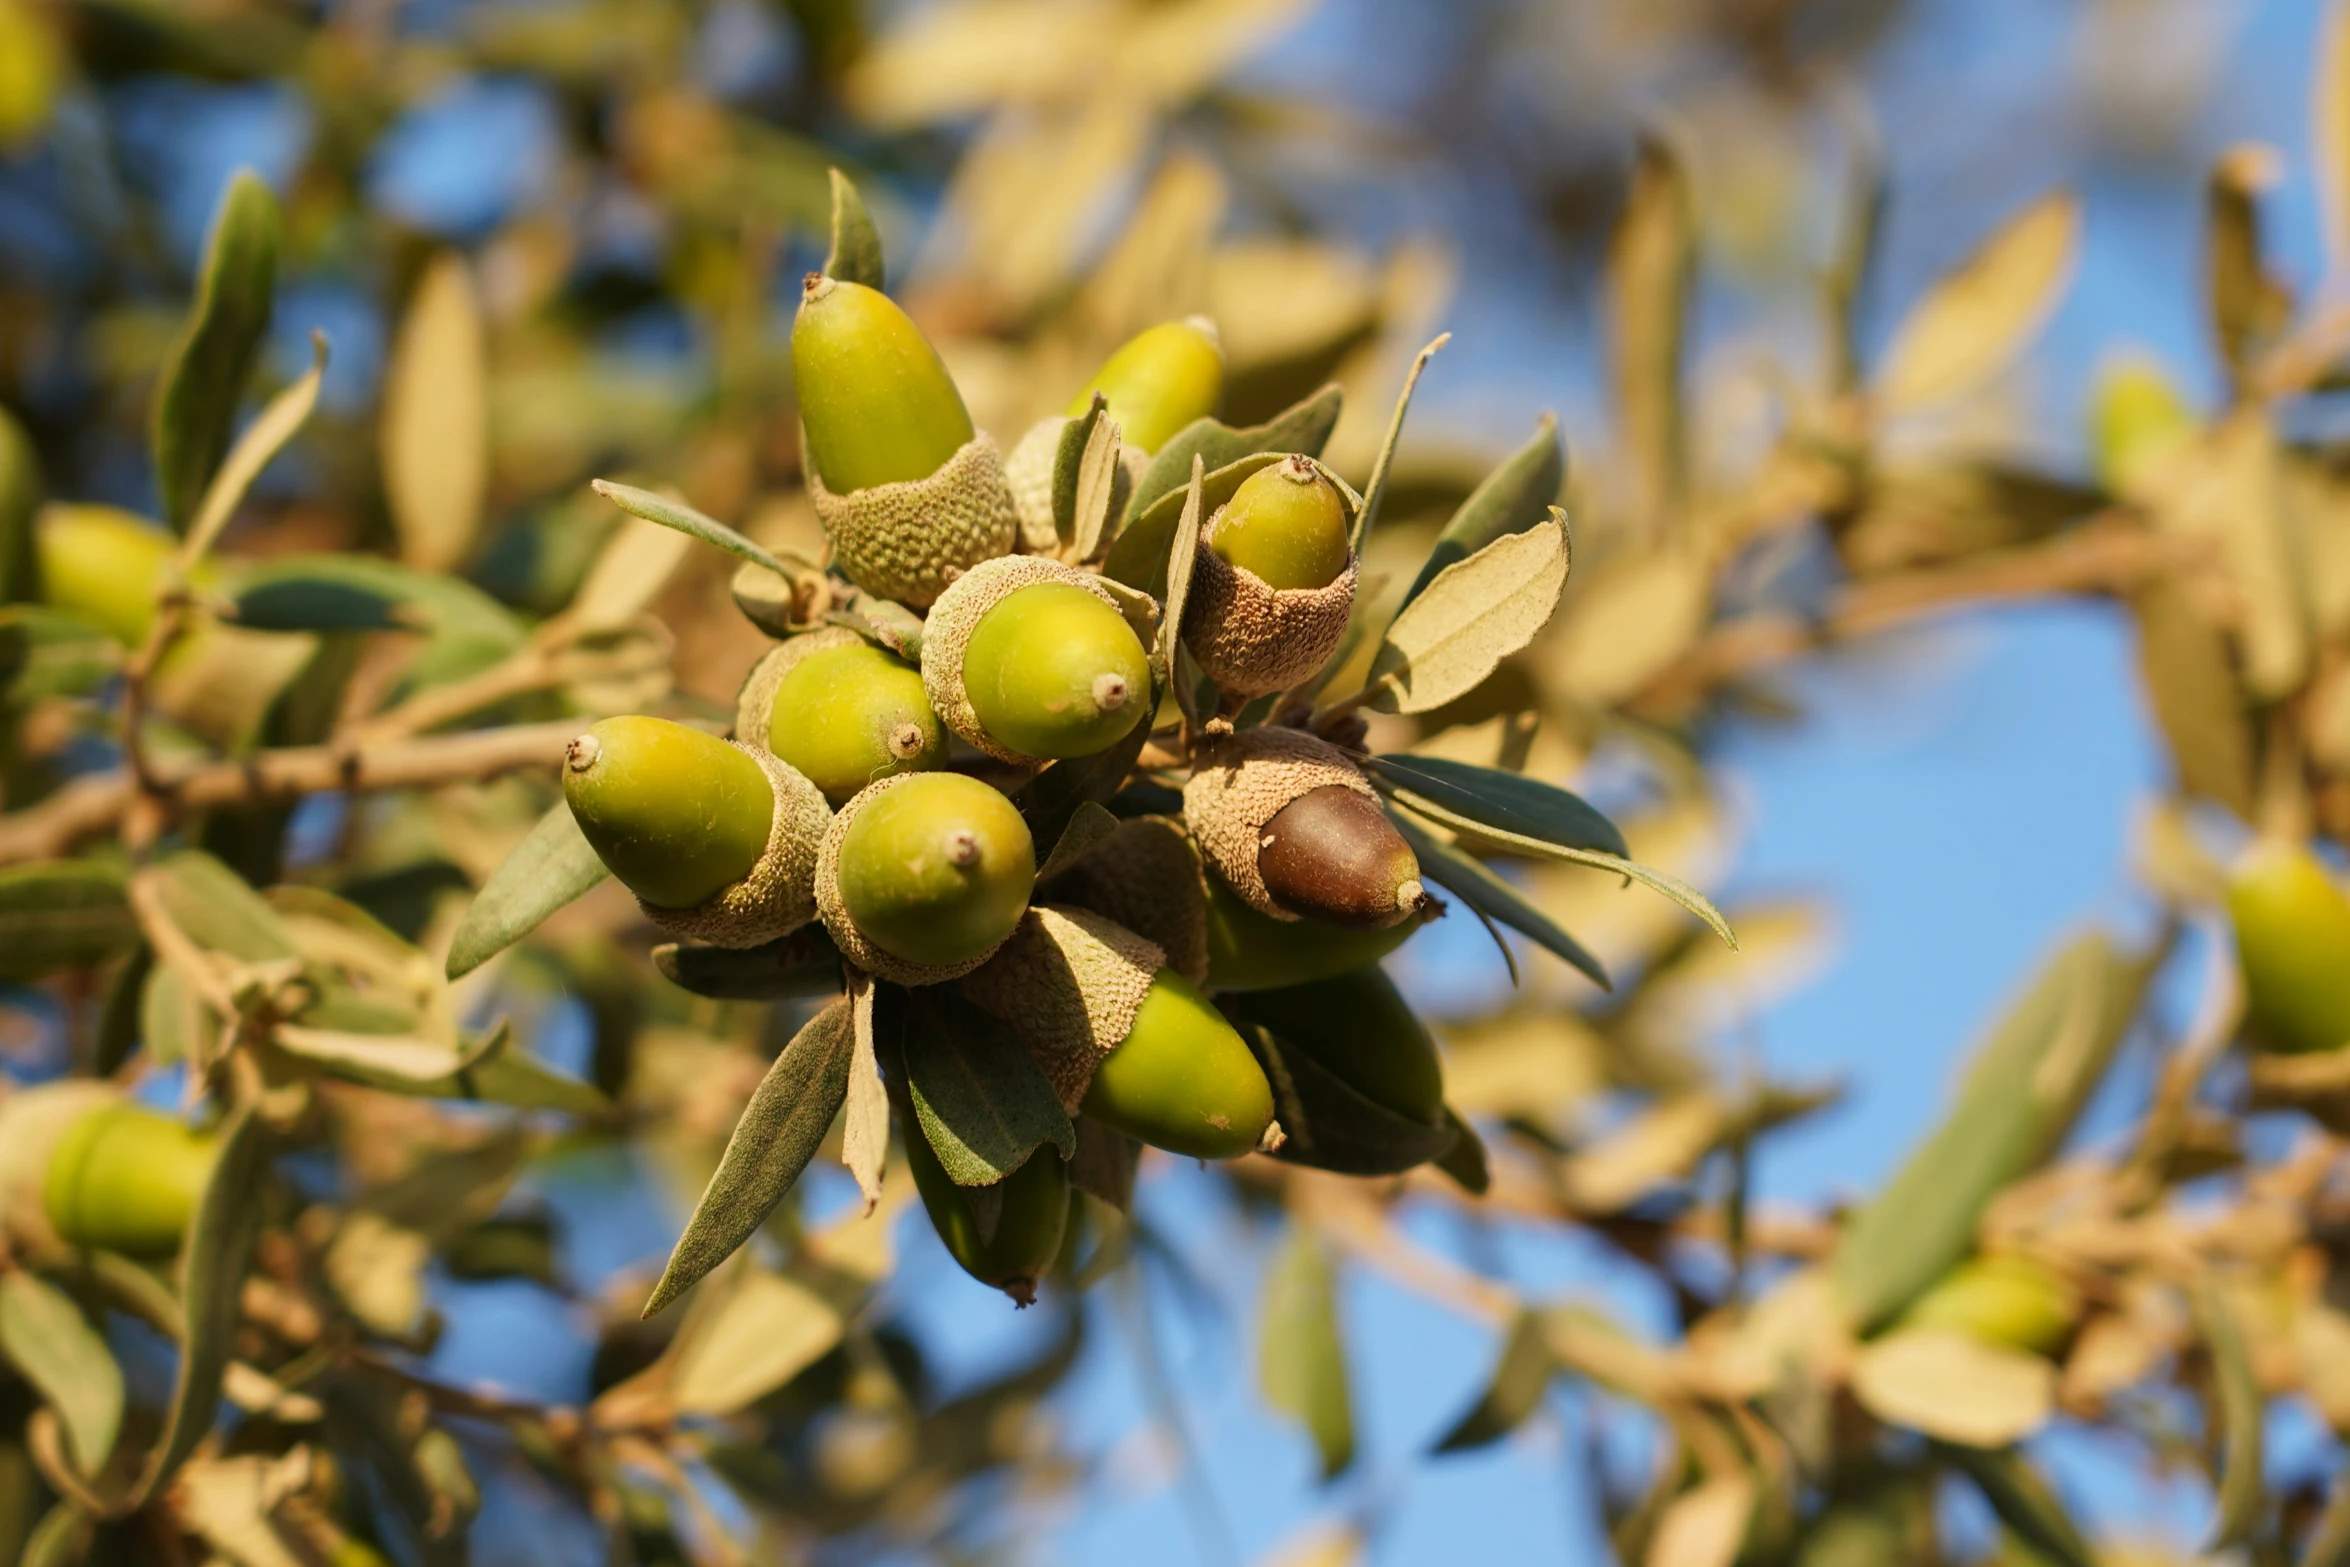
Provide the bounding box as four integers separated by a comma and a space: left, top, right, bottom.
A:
153, 169, 280, 533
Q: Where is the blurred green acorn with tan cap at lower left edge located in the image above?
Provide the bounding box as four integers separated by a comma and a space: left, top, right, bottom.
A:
0, 1081, 219, 1262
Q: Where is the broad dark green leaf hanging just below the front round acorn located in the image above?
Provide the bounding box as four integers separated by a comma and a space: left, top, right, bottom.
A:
898, 987, 1076, 1186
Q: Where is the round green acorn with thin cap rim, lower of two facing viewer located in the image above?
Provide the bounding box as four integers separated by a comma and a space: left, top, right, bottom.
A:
815, 773, 1036, 984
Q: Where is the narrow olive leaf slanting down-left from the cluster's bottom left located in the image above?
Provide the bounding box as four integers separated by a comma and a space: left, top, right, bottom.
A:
644, 1001, 855, 1316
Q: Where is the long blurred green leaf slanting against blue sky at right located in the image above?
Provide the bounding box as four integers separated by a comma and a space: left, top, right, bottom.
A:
1831, 933, 2148, 1332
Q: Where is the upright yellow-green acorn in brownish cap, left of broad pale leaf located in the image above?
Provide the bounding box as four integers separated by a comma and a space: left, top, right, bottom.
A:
1182, 456, 1356, 698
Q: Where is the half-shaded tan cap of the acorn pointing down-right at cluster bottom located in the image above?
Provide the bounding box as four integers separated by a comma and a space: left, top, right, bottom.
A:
964, 904, 1166, 1116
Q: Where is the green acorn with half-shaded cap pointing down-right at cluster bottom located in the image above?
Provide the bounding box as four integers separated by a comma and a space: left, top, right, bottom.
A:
964, 904, 1274, 1158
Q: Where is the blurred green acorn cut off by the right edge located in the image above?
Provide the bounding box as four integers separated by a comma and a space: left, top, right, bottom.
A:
2228, 839, 2350, 1050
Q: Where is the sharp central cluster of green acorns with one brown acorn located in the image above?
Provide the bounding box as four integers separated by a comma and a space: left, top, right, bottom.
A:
564, 241, 1452, 1302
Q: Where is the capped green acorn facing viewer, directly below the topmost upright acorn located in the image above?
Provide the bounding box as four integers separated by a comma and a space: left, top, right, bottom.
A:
921, 554, 1152, 761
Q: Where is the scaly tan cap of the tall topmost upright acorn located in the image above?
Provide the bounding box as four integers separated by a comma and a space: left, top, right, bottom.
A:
806, 430, 1019, 608
